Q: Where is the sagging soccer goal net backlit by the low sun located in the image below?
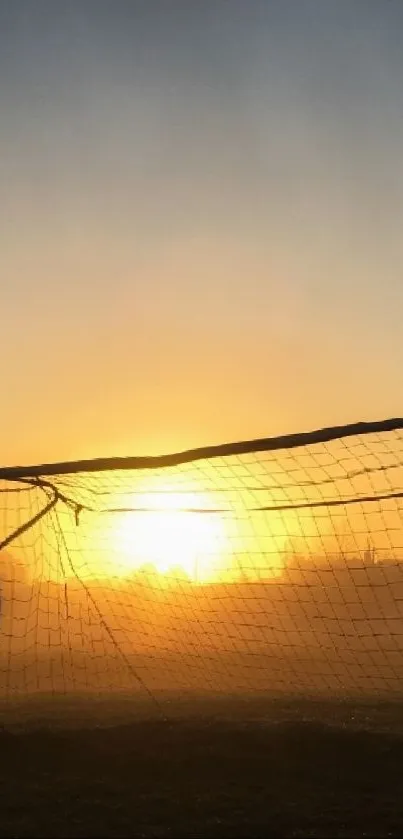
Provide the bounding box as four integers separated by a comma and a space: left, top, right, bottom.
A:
0, 420, 403, 704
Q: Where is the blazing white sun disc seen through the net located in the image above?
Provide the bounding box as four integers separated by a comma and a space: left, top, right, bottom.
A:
114, 492, 228, 582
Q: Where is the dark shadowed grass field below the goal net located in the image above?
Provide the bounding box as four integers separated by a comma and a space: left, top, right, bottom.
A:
0, 701, 403, 837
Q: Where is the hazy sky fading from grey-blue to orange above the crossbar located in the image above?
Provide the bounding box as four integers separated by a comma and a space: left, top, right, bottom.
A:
0, 0, 403, 464
